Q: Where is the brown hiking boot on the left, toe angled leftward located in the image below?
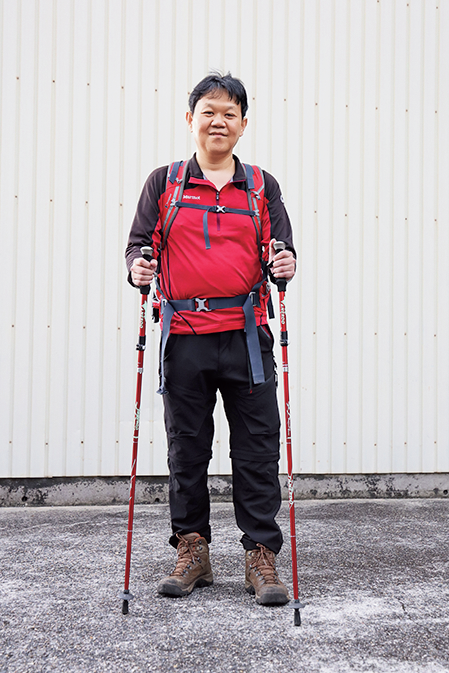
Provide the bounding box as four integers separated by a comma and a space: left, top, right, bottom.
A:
157, 533, 214, 596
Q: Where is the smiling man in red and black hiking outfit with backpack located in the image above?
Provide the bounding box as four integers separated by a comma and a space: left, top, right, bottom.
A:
126, 73, 295, 605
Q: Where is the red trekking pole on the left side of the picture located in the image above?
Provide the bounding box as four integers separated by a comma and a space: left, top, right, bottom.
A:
119, 246, 153, 615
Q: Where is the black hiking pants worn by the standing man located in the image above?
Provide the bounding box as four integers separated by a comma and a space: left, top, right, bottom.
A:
163, 327, 282, 554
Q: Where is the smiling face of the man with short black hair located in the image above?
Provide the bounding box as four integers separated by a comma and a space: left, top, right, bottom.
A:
186, 91, 248, 157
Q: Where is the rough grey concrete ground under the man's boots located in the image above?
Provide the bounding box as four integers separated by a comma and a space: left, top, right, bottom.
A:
0, 499, 449, 673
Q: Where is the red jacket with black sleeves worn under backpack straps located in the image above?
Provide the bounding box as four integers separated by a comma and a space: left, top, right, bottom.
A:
126, 156, 294, 334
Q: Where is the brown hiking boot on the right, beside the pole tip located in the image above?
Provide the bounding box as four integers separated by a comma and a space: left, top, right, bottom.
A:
245, 544, 290, 605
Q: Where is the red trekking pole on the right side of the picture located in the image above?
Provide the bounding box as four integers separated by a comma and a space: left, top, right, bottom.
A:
274, 241, 304, 626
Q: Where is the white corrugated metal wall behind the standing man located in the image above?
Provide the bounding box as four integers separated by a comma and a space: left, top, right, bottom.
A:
0, 0, 449, 477
